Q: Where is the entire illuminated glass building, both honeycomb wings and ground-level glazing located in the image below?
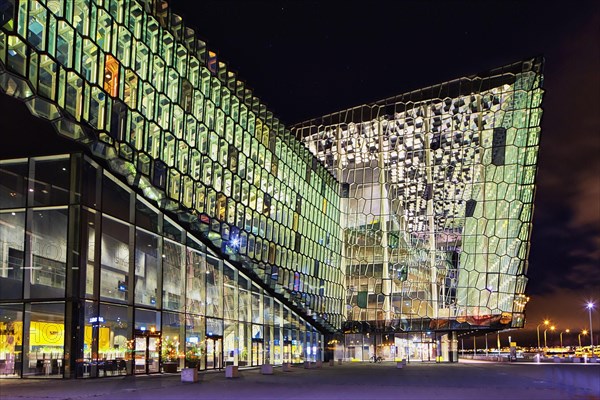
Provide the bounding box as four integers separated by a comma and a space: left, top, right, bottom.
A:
0, 0, 542, 377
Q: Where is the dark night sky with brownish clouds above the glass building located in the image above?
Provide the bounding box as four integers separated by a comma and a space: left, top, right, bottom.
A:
0, 0, 600, 346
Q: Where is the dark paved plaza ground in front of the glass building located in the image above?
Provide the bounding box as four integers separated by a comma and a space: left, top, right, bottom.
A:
0, 362, 600, 400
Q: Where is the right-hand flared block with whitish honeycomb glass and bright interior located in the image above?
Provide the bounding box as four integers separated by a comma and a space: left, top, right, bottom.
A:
292, 59, 542, 362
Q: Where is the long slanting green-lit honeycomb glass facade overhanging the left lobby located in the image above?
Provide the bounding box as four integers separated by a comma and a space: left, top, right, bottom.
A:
0, 1, 343, 329
